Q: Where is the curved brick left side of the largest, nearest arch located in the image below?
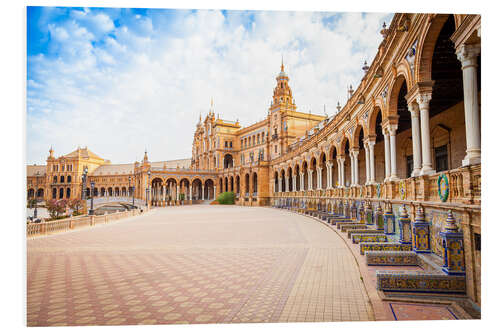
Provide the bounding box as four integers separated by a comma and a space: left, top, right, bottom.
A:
415, 14, 455, 82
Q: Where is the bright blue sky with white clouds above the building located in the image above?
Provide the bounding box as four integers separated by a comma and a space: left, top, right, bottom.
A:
26, 7, 393, 164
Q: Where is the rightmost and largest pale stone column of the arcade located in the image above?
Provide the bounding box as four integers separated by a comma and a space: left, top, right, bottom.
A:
457, 44, 481, 166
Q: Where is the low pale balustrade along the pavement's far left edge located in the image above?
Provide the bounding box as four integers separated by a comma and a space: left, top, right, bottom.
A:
26, 209, 141, 238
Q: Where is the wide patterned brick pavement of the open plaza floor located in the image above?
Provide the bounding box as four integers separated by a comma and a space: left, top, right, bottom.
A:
27, 206, 374, 326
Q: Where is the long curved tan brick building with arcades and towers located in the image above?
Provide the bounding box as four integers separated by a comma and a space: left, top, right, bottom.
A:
27, 13, 481, 304
